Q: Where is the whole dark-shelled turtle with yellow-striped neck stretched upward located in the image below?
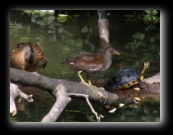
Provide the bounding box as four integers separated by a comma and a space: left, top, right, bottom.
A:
106, 62, 150, 91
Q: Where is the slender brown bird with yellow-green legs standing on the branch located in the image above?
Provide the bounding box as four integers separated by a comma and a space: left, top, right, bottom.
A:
61, 46, 120, 86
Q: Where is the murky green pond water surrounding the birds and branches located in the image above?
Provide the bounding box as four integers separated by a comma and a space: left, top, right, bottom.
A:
10, 12, 160, 122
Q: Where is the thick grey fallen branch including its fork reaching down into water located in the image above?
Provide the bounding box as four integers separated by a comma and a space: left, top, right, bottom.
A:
10, 68, 135, 122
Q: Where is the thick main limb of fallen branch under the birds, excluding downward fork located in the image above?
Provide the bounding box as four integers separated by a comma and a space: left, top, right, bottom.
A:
10, 68, 137, 105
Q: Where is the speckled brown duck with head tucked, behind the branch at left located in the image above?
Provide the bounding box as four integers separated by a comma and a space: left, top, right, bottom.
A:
10, 41, 47, 73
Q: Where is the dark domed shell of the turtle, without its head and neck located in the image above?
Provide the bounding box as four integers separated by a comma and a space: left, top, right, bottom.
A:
107, 68, 140, 90
